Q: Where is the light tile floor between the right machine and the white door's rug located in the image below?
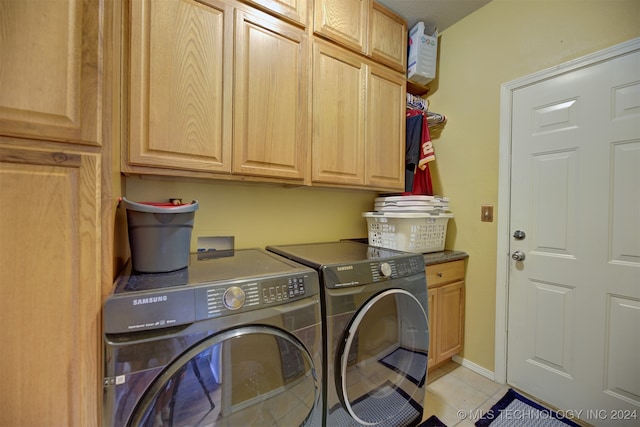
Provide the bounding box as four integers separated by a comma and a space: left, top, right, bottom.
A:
424, 362, 509, 427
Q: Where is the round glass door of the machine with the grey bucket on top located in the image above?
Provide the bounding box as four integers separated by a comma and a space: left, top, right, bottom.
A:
129, 326, 321, 427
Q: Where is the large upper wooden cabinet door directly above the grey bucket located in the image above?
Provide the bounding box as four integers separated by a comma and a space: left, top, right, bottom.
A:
123, 0, 233, 172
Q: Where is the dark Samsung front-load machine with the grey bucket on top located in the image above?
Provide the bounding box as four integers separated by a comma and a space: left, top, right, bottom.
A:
103, 249, 323, 427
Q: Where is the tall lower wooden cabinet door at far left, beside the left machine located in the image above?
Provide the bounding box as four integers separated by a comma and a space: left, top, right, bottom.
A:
0, 145, 102, 427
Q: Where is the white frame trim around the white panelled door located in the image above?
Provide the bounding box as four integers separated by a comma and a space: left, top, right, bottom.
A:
494, 38, 640, 384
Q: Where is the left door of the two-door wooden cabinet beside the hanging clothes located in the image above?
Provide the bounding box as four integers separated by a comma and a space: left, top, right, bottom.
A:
311, 40, 367, 185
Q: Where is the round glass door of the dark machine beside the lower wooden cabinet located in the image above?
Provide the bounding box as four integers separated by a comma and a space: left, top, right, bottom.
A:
334, 289, 429, 425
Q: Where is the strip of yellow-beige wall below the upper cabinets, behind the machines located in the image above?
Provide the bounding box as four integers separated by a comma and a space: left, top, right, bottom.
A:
126, 177, 376, 250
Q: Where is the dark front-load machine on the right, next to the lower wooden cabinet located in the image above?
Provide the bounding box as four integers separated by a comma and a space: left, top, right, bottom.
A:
267, 241, 429, 427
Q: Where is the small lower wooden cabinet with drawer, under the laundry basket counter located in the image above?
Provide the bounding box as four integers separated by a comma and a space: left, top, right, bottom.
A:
426, 260, 464, 369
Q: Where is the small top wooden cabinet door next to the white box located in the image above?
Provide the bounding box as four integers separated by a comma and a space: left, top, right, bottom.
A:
369, 1, 408, 73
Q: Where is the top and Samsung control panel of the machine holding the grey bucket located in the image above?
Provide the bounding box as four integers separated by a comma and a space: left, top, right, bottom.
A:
103, 249, 320, 334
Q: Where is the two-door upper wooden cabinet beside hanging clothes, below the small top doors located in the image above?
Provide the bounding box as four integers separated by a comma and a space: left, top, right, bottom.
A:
311, 40, 406, 191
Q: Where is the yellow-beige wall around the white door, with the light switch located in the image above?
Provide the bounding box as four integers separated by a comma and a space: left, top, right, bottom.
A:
429, 0, 640, 371
